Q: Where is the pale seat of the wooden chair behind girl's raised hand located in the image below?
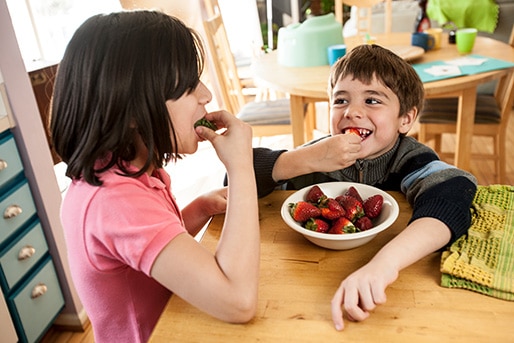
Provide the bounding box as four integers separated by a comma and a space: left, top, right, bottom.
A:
237, 98, 291, 125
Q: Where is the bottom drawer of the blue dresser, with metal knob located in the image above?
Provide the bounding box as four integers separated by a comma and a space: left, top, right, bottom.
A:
9, 257, 64, 342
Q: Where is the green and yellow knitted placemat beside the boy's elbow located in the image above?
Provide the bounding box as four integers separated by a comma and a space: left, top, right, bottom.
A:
441, 185, 514, 301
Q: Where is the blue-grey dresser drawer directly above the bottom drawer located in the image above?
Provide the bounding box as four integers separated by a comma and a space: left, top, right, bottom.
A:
0, 222, 48, 292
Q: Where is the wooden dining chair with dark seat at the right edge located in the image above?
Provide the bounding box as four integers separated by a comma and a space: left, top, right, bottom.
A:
418, 25, 514, 184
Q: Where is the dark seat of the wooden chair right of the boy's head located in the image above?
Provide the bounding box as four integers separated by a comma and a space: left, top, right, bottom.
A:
419, 95, 501, 124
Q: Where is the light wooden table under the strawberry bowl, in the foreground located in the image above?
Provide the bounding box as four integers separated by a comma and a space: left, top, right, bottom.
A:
150, 191, 514, 343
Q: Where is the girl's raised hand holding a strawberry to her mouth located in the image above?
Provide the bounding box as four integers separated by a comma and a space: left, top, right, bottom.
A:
195, 111, 253, 169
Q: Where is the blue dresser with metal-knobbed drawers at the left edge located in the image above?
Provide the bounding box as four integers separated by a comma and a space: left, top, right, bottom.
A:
0, 130, 64, 342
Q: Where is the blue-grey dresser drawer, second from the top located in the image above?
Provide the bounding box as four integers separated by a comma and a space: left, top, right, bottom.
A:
0, 181, 36, 245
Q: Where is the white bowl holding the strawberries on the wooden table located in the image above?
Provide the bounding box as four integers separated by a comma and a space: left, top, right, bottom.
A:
280, 182, 400, 250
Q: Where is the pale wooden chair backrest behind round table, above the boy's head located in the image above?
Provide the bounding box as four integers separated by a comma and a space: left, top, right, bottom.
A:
335, 0, 393, 35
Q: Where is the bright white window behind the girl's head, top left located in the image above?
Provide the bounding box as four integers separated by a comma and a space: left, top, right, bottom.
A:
7, 0, 122, 64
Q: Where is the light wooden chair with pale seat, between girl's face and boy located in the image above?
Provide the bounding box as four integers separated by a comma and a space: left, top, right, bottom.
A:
201, 0, 292, 137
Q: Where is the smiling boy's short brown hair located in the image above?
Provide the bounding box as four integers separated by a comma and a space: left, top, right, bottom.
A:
328, 44, 425, 116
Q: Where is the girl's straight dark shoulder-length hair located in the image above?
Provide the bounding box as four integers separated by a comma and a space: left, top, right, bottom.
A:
50, 11, 204, 185
